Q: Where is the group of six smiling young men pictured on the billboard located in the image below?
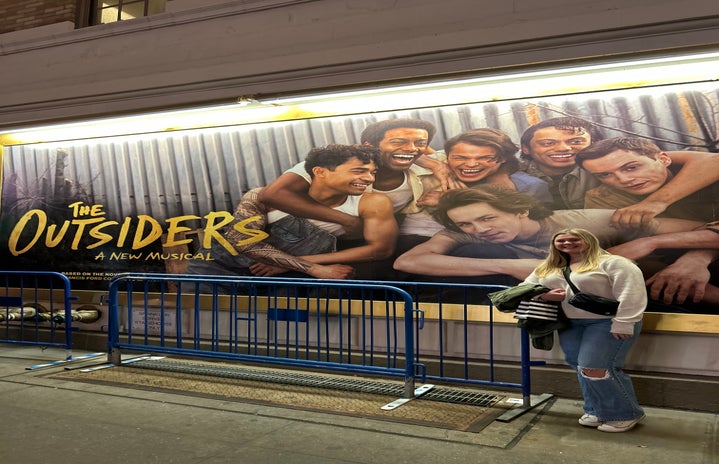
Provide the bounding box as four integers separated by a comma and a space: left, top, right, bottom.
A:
188, 117, 719, 312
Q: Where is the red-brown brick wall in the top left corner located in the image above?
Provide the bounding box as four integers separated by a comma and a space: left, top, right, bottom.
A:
0, 0, 77, 34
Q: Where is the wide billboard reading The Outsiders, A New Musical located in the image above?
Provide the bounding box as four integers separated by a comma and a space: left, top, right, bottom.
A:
0, 83, 719, 314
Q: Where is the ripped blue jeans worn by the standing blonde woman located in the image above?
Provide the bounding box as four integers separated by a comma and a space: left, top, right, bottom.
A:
559, 319, 644, 421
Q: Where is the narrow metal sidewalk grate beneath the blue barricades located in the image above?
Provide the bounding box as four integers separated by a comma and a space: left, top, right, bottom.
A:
132, 359, 502, 407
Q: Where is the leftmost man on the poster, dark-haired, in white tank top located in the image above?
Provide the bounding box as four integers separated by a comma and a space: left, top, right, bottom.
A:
188, 145, 398, 279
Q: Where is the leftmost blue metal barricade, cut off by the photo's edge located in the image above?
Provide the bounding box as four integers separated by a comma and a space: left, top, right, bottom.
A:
0, 271, 74, 360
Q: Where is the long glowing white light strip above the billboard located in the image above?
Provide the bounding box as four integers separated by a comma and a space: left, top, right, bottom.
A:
0, 52, 719, 145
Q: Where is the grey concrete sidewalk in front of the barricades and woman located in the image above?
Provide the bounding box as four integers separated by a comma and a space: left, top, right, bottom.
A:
0, 344, 719, 464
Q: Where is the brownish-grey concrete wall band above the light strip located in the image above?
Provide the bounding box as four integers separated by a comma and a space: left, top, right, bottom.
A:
0, 0, 719, 125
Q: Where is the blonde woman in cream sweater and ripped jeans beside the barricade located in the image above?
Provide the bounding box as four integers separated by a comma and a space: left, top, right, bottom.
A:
525, 229, 647, 432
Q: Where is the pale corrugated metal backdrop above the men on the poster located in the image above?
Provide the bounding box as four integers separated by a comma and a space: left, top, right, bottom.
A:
3, 85, 719, 226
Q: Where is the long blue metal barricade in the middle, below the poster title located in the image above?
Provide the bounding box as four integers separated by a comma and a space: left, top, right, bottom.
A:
108, 273, 423, 397
